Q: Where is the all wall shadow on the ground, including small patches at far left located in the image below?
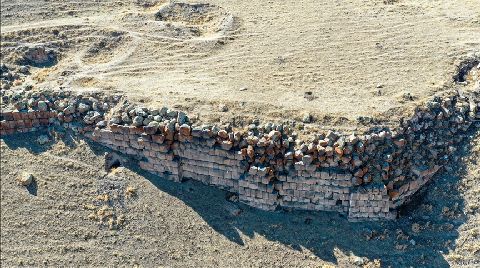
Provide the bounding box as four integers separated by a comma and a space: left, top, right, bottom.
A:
3, 126, 478, 267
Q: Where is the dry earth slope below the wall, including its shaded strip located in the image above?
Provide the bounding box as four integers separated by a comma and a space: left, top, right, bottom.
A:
1, 129, 480, 267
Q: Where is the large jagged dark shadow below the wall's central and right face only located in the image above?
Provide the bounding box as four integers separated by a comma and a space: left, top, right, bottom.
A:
129, 164, 464, 267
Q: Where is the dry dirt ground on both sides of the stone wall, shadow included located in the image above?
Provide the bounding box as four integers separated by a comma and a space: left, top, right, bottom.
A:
0, 0, 480, 267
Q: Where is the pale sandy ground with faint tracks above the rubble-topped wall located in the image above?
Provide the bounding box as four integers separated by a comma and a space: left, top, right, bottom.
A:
1, 0, 480, 128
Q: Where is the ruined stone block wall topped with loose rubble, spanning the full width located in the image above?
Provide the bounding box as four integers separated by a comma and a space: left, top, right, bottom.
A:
0, 89, 480, 220
